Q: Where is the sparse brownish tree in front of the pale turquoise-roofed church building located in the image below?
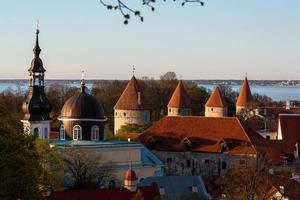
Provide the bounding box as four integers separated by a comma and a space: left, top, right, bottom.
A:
63, 147, 112, 189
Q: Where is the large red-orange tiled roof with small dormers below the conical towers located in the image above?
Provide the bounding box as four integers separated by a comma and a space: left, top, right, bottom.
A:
139, 116, 264, 154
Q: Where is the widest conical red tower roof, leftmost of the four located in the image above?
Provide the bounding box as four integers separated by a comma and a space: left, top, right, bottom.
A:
114, 76, 148, 110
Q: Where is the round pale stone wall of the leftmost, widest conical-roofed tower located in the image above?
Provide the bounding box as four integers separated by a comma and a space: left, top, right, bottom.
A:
114, 110, 150, 134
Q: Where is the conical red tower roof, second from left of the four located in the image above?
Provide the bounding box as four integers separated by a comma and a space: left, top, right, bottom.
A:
168, 81, 192, 108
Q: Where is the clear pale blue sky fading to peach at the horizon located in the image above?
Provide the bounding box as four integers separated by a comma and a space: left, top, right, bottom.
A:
0, 0, 300, 80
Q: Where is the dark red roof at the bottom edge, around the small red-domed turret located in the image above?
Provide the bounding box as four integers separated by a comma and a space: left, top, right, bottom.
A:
48, 183, 160, 200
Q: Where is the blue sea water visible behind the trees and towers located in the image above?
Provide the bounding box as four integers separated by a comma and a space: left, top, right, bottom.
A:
0, 81, 300, 101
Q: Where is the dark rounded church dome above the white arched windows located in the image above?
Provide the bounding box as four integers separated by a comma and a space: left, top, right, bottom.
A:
60, 91, 105, 119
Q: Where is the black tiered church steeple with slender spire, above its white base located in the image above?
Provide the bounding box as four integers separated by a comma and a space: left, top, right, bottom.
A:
22, 28, 51, 121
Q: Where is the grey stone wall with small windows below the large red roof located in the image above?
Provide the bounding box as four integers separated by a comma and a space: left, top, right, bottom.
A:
153, 151, 255, 176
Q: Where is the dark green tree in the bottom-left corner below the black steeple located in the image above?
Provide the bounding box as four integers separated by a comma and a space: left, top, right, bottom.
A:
0, 106, 42, 199
